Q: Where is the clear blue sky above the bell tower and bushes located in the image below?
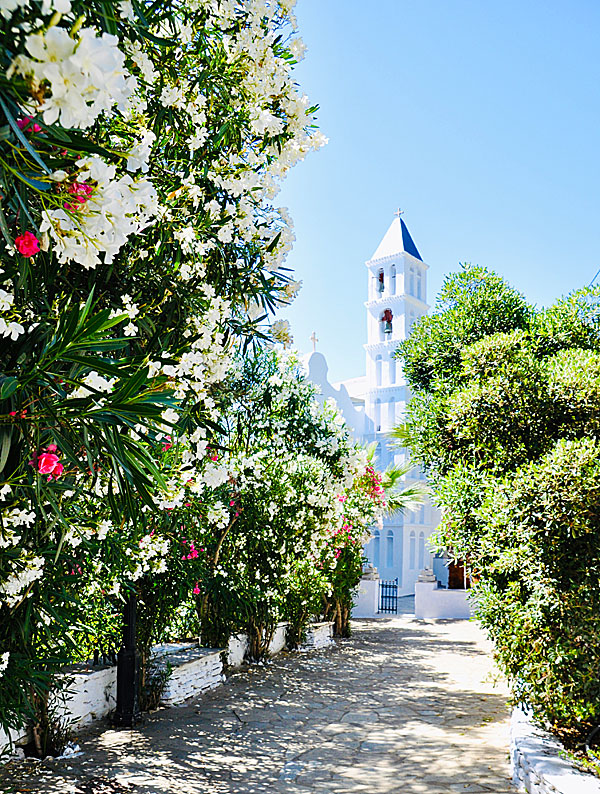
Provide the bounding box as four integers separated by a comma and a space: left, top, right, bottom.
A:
278, 0, 600, 381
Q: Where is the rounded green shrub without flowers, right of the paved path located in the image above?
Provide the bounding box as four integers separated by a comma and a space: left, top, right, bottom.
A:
399, 266, 600, 745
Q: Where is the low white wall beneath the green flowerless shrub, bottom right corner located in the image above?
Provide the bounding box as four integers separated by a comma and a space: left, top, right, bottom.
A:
510, 709, 600, 794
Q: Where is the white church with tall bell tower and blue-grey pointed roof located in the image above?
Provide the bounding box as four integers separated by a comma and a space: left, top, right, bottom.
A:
307, 212, 438, 595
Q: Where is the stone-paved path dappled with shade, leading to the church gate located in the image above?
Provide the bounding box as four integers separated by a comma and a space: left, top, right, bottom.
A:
0, 615, 515, 794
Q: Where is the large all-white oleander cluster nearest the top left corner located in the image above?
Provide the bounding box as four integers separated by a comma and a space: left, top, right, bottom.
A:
9, 26, 137, 129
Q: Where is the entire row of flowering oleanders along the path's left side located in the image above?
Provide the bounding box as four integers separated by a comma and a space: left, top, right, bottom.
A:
0, 0, 422, 756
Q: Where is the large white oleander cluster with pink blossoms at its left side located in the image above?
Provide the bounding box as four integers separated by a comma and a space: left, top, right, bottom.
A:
40, 155, 158, 269
